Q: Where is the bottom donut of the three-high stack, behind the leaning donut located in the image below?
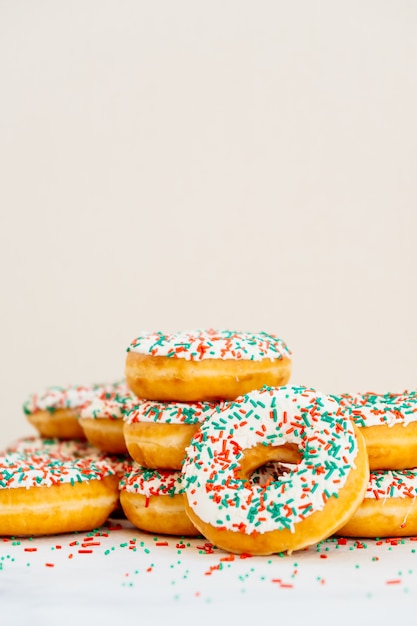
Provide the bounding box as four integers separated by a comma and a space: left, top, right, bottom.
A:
120, 465, 199, 536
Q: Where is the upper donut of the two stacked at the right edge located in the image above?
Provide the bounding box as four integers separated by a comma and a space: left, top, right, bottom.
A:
332, 391, 417, 470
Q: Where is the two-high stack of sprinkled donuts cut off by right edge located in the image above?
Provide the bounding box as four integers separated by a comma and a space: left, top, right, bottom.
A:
334, 391, 417, 537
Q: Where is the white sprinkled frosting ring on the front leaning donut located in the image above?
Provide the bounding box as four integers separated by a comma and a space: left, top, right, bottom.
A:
183, 387, 358, 534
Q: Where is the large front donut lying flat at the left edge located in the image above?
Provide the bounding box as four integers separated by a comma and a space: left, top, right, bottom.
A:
0, 450, 119, 536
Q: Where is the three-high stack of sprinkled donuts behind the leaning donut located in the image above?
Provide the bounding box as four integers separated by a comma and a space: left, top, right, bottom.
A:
120, 330, 291, 535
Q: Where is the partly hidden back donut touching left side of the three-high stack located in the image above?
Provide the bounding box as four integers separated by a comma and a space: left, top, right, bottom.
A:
79, 385, 138, 454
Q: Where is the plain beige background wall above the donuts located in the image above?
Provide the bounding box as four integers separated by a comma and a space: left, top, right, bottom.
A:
0, 0, 417, 446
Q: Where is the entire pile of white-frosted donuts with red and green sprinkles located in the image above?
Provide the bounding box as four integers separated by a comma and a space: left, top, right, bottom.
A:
0, 330, 417, 555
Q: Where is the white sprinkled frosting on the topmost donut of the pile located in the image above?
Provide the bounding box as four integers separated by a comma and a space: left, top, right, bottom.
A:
128, 330, 291, 361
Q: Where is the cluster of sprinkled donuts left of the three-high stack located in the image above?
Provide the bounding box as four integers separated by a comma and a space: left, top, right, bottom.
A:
4, 381, 136, 535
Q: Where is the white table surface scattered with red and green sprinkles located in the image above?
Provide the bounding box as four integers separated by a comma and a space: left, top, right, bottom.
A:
0, 519, 417, 626
